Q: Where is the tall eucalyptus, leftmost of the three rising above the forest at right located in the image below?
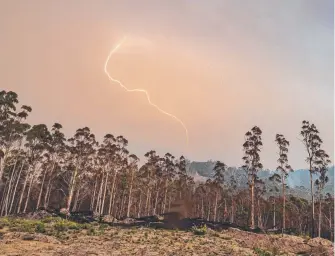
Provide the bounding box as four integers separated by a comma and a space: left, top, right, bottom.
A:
242, 126, 263, 228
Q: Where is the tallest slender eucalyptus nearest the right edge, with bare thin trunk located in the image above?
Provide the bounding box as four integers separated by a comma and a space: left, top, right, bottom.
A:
300, 120, 327, 237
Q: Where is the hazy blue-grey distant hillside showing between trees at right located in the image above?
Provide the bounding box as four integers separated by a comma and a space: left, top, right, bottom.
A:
187, 161, 334, 197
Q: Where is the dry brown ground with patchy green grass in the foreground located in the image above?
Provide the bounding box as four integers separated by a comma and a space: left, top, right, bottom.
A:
0, 227, 334, 256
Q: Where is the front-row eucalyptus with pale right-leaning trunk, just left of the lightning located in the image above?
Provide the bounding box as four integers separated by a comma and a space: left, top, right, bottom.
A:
66, 127, 97, 212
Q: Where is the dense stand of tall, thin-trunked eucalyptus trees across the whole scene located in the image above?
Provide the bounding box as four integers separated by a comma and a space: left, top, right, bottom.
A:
0, 90, 334, 239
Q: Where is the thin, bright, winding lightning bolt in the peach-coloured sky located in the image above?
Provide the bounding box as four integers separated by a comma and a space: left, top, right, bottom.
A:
104, 38, 189, 144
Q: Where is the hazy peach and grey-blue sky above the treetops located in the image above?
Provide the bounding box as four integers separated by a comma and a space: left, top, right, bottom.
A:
0, 0, 334, 169
